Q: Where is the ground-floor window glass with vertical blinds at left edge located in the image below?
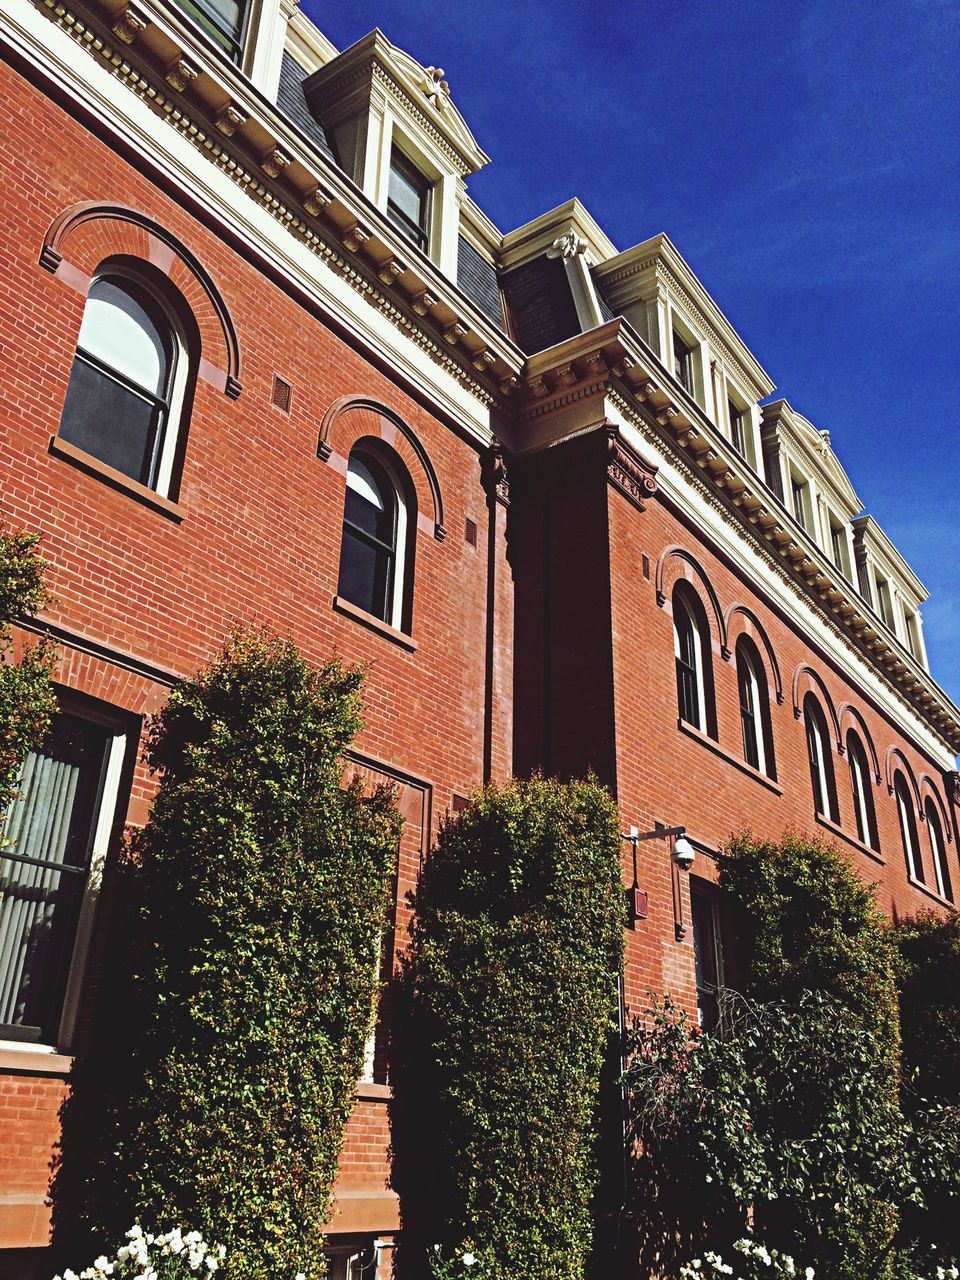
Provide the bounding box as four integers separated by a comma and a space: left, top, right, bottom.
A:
0, 716, 108, 1041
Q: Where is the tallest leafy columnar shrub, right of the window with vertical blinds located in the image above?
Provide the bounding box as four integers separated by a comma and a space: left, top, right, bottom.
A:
67, 634, 399, 1280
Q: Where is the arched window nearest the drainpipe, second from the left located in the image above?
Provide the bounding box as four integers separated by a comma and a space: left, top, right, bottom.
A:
337, 444, 416, 630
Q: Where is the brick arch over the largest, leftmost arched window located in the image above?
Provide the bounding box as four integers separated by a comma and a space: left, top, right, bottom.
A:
40, 200, 241, 399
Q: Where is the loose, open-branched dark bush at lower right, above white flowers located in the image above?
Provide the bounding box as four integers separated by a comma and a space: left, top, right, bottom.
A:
626, 991, 915, 1280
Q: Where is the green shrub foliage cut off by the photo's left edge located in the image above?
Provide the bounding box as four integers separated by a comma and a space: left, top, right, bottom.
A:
0, 531, 56, 814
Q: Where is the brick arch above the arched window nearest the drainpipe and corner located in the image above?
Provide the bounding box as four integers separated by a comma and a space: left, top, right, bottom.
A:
317, 396, 447, 543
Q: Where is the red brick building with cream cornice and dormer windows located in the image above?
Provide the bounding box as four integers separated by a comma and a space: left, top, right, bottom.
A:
0, 0, 960, 1280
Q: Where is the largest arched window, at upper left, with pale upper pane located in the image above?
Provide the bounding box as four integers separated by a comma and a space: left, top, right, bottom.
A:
59, 268, 188, 494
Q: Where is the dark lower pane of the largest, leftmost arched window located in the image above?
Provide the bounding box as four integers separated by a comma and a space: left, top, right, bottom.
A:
60, 356, 163, 484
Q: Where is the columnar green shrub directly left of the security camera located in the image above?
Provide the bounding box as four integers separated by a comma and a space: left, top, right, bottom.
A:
394, 778, 625, 1280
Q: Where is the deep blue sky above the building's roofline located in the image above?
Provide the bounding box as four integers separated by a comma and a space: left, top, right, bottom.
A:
308, 0, 960, 701
